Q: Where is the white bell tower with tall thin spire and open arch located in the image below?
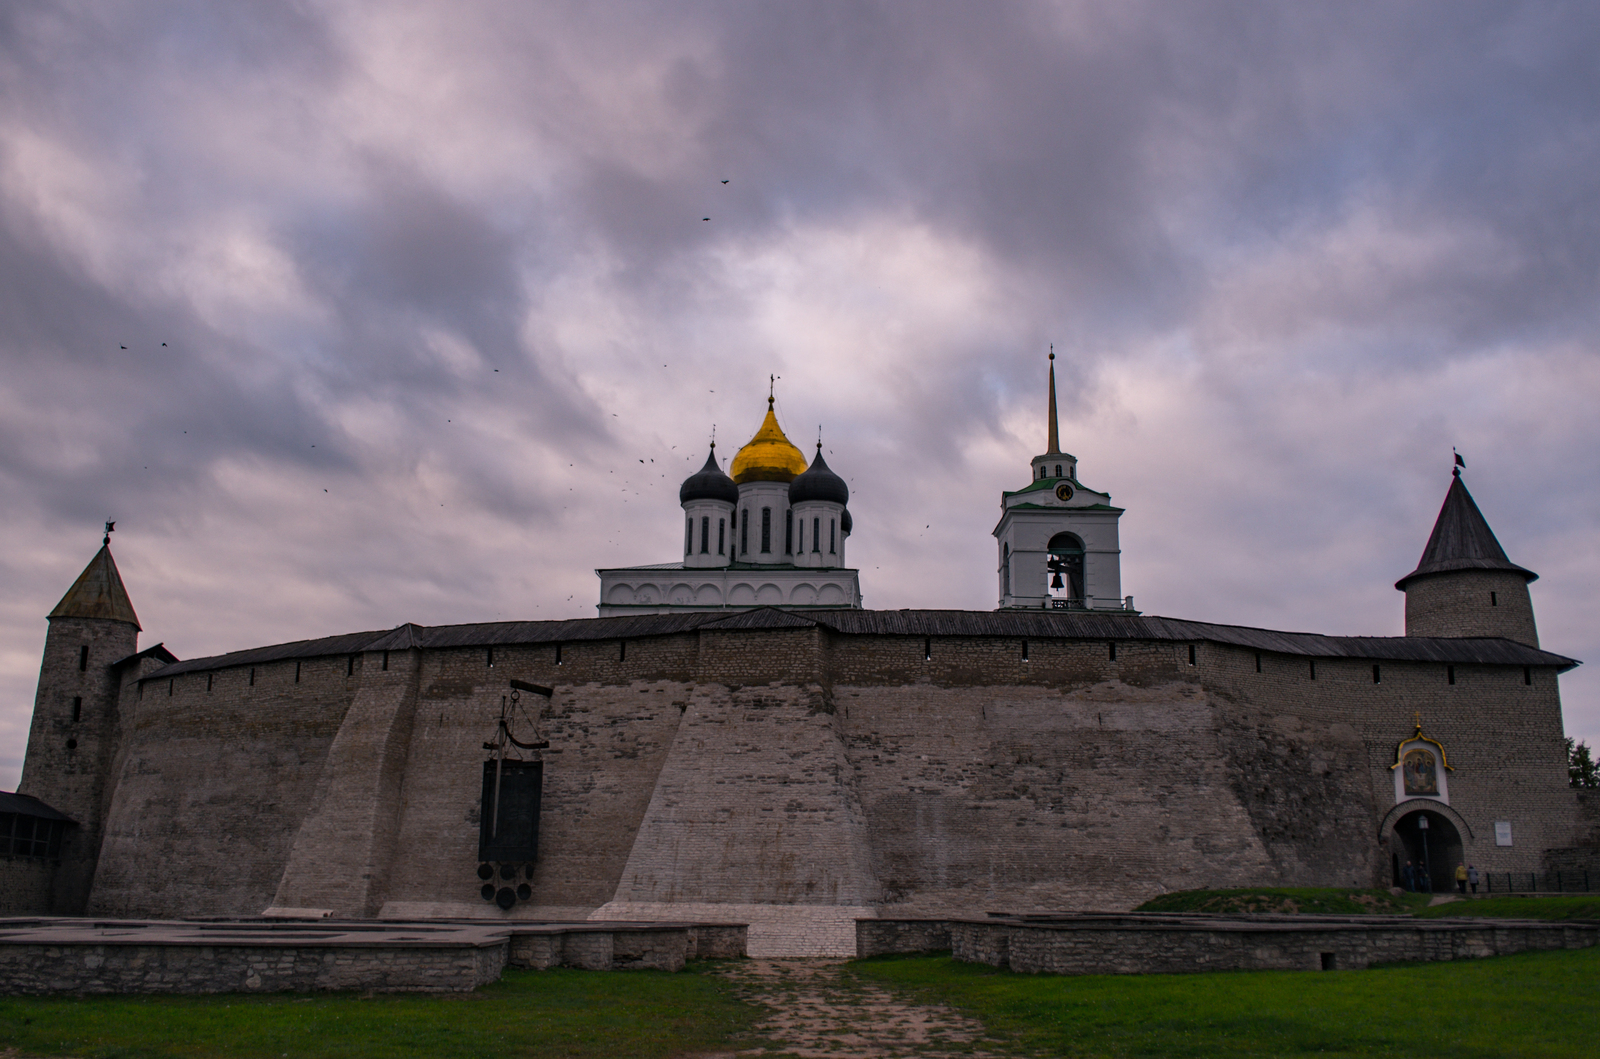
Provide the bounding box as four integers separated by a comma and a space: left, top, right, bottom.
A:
994, 350, 1138, 614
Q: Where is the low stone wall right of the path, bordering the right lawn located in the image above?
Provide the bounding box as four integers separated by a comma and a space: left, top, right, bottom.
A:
856, 913, 1600, 974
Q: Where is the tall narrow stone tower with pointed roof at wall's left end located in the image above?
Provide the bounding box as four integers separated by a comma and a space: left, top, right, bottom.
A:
18, 534, 139, 915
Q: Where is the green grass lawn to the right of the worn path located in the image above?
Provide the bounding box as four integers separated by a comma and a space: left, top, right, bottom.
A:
851, 949, 1600, 1059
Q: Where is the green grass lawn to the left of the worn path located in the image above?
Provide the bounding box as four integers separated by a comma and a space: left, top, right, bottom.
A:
0, 965, 760, 1059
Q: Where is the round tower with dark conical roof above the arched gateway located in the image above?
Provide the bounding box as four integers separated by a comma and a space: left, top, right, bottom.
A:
1395, 467, 1539, 648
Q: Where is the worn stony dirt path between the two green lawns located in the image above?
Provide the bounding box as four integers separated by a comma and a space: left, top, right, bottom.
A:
707, 960, 1000, 1059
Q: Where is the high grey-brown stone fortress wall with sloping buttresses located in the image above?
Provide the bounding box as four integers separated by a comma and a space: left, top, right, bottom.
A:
62, 609, 1581, 918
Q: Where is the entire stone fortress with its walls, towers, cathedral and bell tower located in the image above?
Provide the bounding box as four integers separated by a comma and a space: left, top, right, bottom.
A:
0, 361, 1600, 955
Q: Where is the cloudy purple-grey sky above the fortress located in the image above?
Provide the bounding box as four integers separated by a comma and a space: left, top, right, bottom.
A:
0, 0, 1600, 789
